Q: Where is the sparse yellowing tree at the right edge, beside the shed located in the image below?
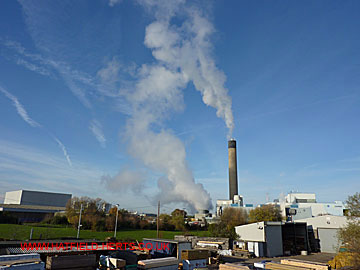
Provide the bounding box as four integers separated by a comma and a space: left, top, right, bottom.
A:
338, 192, 360, 269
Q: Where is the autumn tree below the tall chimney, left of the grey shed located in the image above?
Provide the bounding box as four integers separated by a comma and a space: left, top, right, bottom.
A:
209, 207, 247, 240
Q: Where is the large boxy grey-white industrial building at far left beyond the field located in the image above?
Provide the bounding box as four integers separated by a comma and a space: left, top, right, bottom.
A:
0, 190, 72, 223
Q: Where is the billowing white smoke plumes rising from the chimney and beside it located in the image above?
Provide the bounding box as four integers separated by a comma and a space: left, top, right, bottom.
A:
121, 0, 234, 210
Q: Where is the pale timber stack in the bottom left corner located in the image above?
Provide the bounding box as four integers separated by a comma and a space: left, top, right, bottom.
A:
0, 253, 45, 270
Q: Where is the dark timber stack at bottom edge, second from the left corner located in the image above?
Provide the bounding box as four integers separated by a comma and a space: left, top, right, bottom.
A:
46, 254, 96, 270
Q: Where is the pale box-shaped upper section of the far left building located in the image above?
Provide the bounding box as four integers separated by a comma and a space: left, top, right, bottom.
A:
4, 190, 71, 207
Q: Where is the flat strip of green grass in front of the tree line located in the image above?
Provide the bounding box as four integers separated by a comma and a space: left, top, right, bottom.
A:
0, 224, 209, 241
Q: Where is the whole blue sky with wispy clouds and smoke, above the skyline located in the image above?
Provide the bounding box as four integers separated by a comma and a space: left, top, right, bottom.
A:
0, 0, 360, 212
